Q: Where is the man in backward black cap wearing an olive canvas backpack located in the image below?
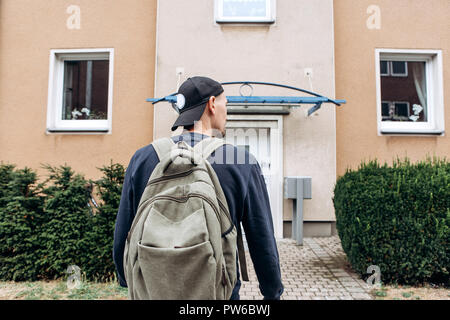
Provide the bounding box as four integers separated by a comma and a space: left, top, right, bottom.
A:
113, 77, 283, 300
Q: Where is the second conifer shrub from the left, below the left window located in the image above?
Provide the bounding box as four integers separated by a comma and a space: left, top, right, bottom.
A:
40, 165, 91, 279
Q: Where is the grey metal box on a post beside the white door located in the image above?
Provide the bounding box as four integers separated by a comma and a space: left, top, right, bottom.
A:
284, 177, 312, 245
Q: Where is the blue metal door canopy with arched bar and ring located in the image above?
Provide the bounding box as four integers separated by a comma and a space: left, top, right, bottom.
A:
147, 81, 346, 116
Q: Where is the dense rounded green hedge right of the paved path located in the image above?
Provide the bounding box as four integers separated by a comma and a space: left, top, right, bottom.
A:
333, 158, 450, 285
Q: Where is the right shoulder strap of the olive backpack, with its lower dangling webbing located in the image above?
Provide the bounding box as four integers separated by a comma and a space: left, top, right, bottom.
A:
194, 137, 249, 281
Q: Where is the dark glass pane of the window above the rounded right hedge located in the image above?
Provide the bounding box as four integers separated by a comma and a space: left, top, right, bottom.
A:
381, 61, 428, 122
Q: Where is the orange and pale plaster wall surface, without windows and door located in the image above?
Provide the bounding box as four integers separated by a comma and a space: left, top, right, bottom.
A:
4, 0, 442, 238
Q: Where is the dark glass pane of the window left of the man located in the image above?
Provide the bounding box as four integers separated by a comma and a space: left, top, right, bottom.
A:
62, 60, 109, 120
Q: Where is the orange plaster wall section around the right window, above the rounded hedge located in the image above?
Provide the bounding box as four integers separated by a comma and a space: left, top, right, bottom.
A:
334, 0, 450, 176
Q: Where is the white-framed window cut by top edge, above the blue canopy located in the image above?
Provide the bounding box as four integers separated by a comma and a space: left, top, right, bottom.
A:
215, 0, 276, 23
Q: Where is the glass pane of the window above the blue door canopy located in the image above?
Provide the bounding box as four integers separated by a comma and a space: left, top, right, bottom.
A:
223, 0, 269, 17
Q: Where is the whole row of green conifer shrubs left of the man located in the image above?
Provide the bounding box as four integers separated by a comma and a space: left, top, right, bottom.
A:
0, 163, 125, 281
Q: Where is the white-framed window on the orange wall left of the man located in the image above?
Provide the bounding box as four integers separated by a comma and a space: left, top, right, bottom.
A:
47, 49, 114, 132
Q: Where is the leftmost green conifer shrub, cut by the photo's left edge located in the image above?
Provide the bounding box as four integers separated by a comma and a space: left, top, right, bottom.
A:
0, 165, 44, 281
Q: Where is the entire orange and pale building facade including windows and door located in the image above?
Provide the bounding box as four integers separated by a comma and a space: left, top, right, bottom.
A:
0, 0, 450, 238
